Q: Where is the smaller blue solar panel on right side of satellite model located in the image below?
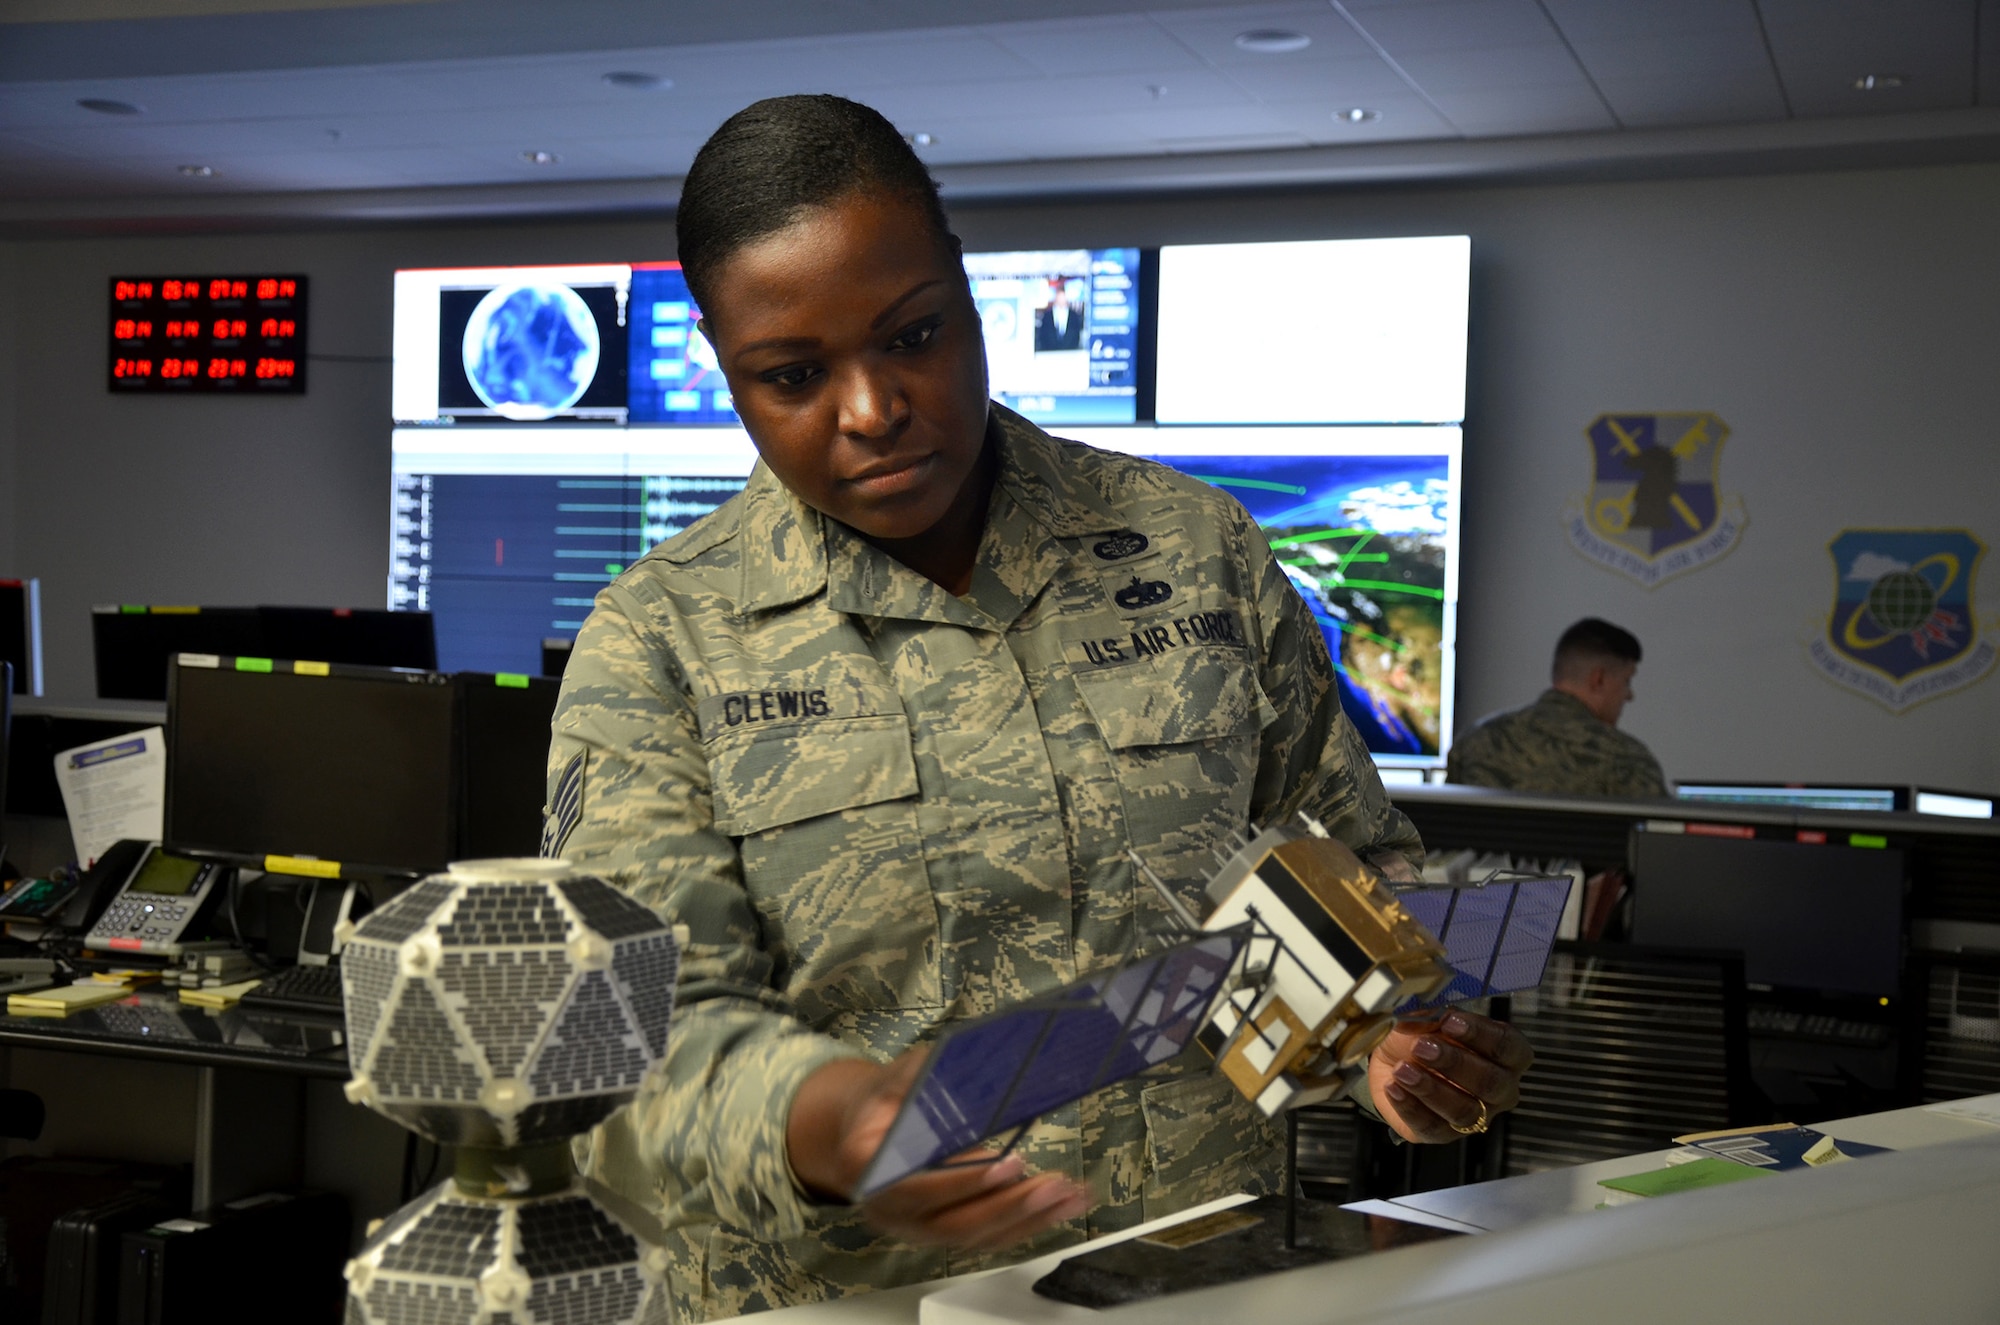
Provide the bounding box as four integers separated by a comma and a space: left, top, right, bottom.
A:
1396, 875, 1572, 1013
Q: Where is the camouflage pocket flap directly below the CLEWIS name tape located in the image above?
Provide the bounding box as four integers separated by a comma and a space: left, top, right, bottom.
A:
706, 693, 918, 837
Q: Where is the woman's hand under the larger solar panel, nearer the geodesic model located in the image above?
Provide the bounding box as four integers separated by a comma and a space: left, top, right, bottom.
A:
786, 1049, 1090, 1251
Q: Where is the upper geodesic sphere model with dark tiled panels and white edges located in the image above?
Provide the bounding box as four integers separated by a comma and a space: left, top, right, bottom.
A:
340, 859, 678, 1149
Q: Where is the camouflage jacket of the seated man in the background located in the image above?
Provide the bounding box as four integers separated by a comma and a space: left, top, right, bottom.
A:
1446, 691, 1666, 799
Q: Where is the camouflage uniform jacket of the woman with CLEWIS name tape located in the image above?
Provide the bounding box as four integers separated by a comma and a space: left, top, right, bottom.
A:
544, 406, 1422, 1321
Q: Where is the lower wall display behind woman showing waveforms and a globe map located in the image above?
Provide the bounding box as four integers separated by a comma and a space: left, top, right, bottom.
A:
390, 426, 1460, 765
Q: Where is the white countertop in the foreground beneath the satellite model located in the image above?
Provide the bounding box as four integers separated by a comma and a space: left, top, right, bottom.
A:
744, 1097, 2000, 1325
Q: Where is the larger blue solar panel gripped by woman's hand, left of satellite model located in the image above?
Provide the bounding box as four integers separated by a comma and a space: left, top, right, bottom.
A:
856, 925, 1250, 1197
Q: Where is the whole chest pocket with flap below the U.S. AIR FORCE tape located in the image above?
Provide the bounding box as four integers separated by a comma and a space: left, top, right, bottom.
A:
1076, 646, 1278, 861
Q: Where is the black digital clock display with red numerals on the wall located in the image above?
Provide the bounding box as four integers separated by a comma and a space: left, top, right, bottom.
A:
110, 276, 306, 394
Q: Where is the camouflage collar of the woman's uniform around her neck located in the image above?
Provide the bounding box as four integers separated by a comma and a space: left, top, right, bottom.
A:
738, 404, 1124, 630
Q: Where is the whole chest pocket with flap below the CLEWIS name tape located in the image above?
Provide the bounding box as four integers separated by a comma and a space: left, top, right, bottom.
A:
704, 687, 942, 1029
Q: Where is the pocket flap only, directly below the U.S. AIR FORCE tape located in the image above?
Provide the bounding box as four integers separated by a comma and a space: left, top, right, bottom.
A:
1076, 648, 1278, 751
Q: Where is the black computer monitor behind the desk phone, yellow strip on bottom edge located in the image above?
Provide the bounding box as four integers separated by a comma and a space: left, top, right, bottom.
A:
166, 654, 458, 871
